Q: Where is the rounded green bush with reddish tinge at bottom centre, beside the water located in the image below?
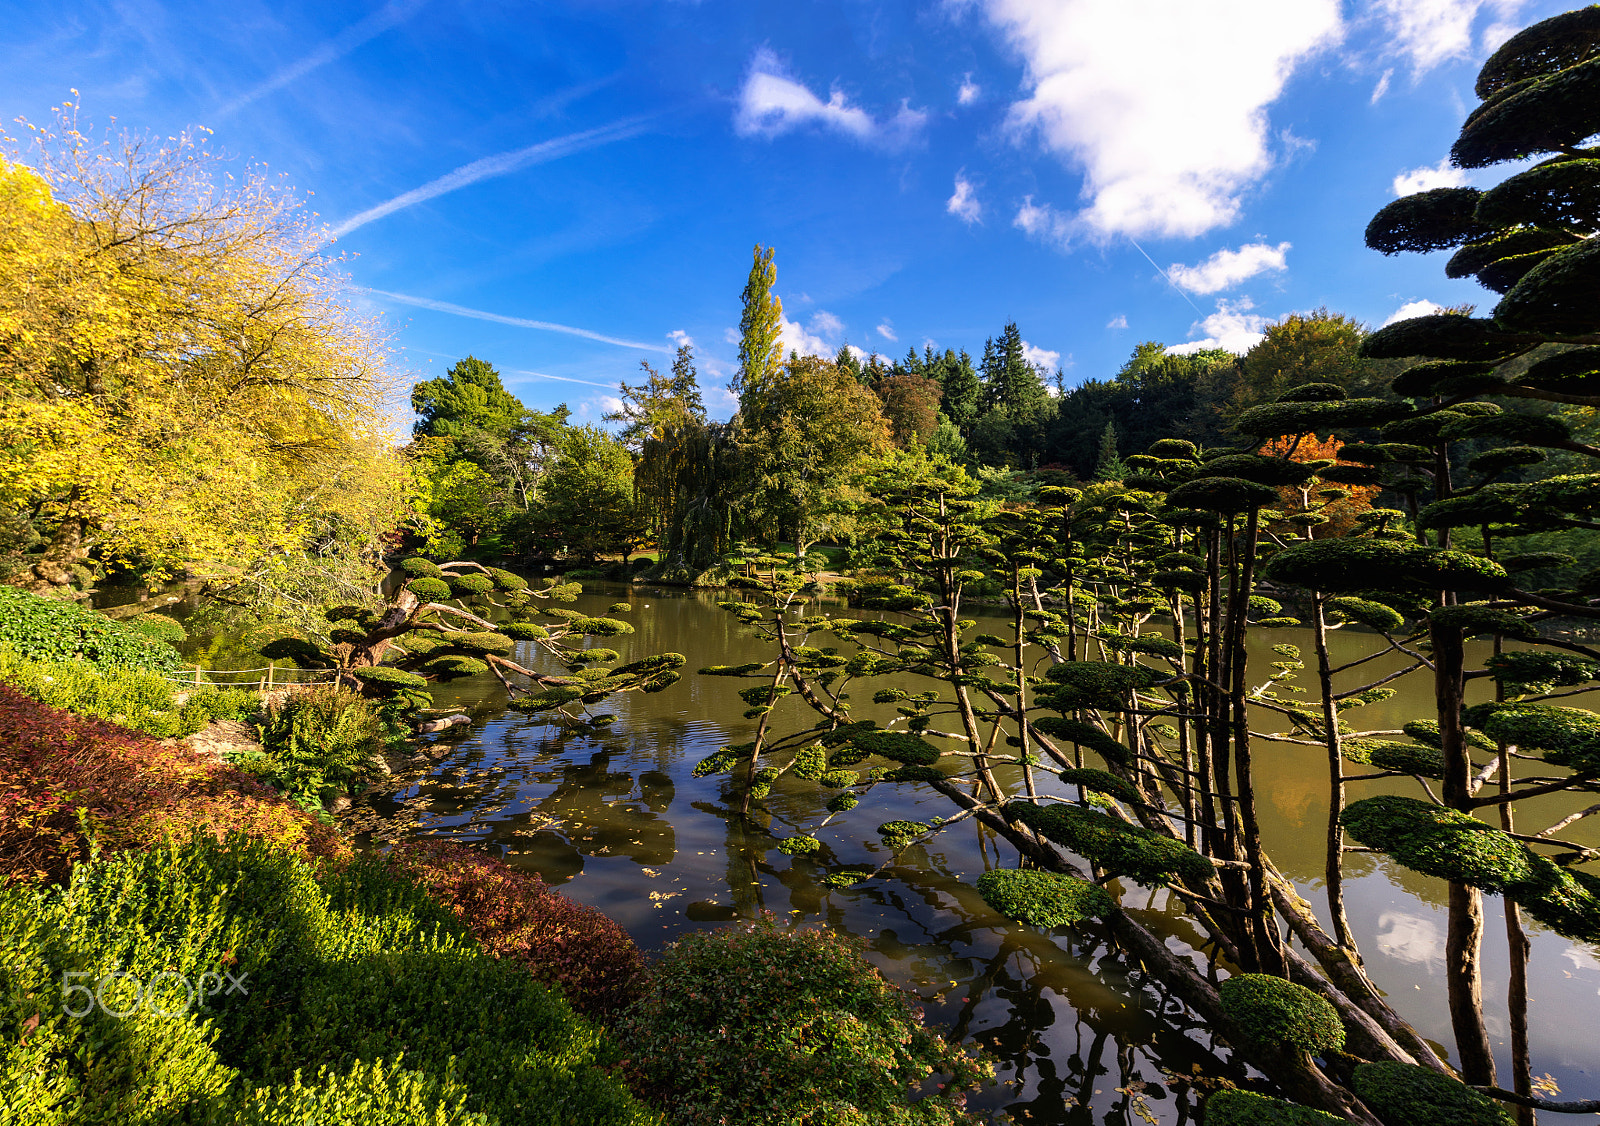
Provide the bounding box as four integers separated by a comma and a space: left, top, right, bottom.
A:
619, 916, 992, 1126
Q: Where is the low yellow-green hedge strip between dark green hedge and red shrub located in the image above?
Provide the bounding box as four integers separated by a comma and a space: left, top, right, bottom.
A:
0, 643, 258, 739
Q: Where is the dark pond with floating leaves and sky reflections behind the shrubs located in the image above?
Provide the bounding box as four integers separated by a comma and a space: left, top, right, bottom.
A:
206, 584, 1600, 1123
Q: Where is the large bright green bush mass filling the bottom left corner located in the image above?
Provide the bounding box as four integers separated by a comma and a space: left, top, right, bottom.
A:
0, 838, 650, 1126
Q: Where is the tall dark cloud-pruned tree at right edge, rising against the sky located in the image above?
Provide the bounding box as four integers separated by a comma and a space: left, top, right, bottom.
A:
1344, 6, 1600, 1094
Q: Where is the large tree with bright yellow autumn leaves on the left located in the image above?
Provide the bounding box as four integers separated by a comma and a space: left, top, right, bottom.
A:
0, 107, 408, 590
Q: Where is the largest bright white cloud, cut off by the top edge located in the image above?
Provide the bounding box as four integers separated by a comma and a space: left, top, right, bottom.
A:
984, 0, 1344, 242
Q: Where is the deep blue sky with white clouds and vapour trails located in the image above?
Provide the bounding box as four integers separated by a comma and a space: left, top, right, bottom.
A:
0, 0, 1570, 419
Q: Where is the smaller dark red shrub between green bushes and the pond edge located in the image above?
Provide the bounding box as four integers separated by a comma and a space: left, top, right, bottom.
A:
377, 838, 645, 1017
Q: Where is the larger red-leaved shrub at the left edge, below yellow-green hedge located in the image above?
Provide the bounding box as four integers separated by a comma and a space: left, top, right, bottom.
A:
0, 685, 349, 884
